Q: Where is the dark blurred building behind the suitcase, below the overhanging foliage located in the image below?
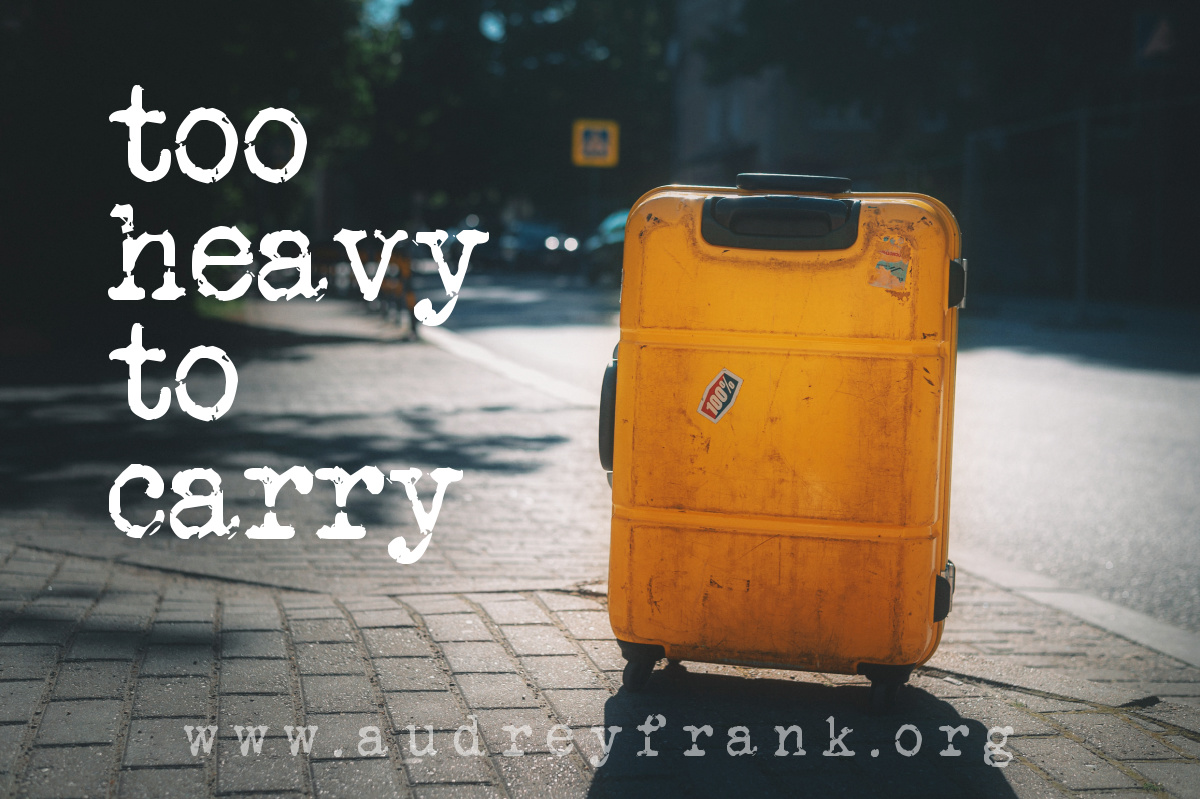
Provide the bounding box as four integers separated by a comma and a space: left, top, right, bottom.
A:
672, 0, 1200, 304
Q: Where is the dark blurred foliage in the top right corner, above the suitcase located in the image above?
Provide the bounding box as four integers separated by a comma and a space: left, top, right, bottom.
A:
704, 0, 1200, 158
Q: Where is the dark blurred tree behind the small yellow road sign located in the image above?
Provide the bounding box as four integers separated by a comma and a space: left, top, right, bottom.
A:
354, 0, 673, 226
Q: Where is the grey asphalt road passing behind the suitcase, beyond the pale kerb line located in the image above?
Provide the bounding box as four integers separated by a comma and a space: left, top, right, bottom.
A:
448, 274, 1200, 631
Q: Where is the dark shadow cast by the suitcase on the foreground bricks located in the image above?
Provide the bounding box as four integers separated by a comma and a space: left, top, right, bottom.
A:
588, 667, 1015, 799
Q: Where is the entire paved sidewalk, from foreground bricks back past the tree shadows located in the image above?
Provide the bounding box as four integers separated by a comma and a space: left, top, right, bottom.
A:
0, 295, 1200, 798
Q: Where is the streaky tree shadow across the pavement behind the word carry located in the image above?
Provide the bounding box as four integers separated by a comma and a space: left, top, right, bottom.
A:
0, 390, 566, 524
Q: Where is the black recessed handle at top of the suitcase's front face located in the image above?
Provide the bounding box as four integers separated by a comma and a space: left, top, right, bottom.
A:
700, 194, 860, 250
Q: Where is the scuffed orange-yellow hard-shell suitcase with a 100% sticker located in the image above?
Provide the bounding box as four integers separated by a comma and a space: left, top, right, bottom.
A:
600, 174, 966, 702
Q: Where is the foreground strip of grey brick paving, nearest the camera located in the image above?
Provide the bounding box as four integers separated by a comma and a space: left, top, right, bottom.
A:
0, 537, 1200, 797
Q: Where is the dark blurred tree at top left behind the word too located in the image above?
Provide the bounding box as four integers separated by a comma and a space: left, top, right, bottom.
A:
0, 0, 386, 355
